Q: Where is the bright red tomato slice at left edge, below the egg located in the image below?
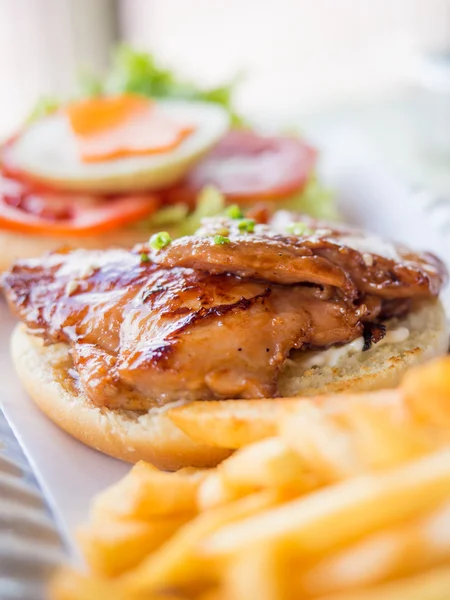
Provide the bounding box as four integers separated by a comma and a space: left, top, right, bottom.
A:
0, 176, 161, 237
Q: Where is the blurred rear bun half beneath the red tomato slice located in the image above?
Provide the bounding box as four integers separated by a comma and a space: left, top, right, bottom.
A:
0, 227, 161, 271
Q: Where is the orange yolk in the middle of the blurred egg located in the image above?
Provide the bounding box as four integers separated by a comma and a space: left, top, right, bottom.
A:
66, 94, 195, 162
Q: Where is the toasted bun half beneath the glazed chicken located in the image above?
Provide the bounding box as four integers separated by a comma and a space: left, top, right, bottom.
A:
12, 301, 448, 470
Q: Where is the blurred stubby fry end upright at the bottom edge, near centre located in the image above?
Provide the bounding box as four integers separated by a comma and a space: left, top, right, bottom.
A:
221, 546, 292, 600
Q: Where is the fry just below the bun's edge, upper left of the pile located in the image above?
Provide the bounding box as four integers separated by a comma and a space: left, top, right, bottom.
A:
91, 461, 206, 522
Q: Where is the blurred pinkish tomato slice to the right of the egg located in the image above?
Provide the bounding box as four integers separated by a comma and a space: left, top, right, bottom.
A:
165, 130, 317, 202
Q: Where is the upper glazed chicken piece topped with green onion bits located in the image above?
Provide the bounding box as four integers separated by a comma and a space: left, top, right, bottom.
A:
153, 211, 445, 298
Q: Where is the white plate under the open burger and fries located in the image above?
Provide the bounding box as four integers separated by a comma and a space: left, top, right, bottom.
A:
0, 132, 450, 568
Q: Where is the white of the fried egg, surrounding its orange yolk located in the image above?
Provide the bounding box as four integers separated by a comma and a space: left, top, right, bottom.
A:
9, 100, 229, 193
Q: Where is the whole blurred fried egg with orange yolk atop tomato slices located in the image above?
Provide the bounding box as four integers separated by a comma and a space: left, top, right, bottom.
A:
4, 99, 229, 194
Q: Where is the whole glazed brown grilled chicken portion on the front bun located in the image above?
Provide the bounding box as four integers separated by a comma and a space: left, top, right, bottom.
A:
3, 214, 446, 410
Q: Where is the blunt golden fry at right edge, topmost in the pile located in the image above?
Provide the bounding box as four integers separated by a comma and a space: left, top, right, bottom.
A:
401, 357, 450, 428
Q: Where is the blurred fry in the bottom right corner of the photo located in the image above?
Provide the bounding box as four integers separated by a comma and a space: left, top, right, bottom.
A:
316, 566, 450, 600
